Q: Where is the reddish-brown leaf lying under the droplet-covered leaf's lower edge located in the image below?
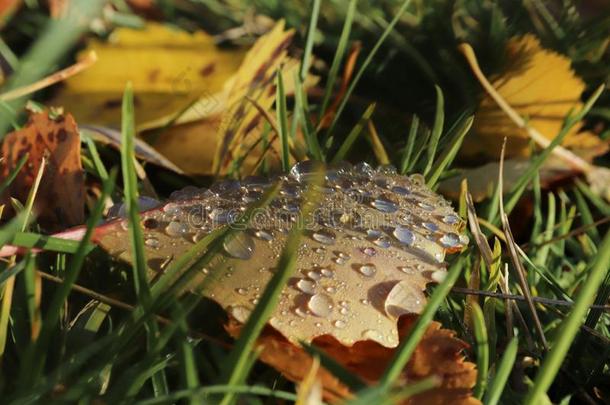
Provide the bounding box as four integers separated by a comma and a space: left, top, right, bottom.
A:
227, 314, 480, 405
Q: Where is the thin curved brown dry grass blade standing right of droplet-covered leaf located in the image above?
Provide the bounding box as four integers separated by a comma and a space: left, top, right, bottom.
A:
498, 138, 548, 350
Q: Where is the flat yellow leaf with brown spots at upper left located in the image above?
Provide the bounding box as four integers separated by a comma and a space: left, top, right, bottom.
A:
52, 23, 244, 127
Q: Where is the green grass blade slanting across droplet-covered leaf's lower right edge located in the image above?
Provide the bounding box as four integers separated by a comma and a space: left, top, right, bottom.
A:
379, 260, 463, 389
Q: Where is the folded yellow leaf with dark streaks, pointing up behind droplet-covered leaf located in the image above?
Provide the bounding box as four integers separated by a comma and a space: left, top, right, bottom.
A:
154, 21, 298, 174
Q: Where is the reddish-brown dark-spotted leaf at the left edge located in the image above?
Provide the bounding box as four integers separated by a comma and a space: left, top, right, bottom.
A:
1, 112, 85, 230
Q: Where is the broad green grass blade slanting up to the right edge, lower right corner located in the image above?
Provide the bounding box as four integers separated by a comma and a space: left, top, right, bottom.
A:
524, 232, 610, 405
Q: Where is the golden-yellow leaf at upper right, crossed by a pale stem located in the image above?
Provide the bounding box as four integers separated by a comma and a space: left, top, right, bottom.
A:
460, 34, 603, 159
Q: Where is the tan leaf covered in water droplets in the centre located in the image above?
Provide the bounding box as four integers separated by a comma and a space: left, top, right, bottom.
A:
97, 162, 467, 347
